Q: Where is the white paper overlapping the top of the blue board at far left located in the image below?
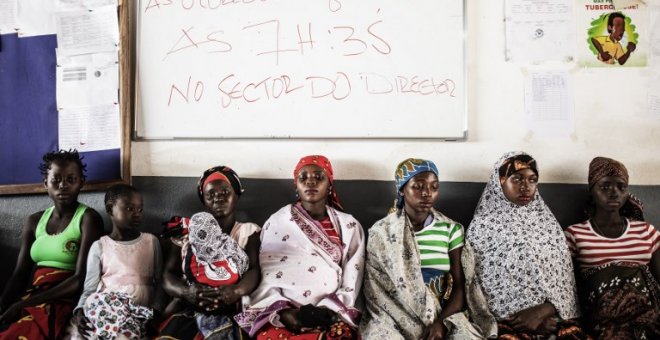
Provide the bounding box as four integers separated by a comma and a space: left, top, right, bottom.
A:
16, 0, 56, 37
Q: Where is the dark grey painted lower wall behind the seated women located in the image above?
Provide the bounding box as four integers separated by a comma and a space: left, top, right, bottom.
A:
0, 177, 660, 287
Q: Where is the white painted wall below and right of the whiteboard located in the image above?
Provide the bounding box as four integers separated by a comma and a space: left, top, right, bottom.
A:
131, 0, 660, 184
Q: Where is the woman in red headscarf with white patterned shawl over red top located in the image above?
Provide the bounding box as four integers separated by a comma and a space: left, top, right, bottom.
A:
235, 155, 365, 339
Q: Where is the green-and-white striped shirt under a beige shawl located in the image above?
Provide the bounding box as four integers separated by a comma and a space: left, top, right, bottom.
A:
415, 221, 463, 272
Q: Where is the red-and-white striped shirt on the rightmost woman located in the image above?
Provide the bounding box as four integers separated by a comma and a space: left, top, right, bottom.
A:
564, 221, 660, 269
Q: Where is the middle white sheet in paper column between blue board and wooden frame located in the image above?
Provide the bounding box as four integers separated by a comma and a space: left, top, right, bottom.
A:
56, 53, 119, 107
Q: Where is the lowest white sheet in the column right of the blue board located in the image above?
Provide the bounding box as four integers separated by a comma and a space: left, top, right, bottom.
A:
58, 104, 120, 152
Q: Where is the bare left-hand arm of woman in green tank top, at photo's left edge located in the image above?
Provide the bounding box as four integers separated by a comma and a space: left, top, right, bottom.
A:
0, 211, 43, 312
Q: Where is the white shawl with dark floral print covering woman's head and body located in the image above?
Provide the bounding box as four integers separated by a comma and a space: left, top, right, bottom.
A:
466, 152, 578, 319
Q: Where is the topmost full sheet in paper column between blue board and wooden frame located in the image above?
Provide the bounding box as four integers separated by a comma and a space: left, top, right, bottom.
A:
56, 6, 119, 55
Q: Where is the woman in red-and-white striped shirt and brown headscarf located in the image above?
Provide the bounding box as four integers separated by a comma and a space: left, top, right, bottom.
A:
565, 157, 660, 339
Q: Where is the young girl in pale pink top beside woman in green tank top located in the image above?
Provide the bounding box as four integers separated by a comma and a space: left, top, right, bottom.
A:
73, 184, 161, 339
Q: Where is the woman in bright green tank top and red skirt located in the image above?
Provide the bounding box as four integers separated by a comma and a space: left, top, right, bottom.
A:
0, 150, 103, 340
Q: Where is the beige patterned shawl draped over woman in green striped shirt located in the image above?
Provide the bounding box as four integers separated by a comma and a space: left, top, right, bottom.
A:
360, 210, 481, 339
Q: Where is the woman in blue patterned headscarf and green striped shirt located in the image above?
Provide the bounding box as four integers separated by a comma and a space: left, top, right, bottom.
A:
360, 158, 482, 339
